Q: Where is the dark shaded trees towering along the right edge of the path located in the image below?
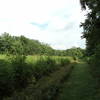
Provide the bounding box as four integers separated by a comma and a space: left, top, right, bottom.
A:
80, 0, 100, 77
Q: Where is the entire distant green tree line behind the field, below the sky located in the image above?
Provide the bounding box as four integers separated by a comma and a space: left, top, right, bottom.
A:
0, 32, 85, 58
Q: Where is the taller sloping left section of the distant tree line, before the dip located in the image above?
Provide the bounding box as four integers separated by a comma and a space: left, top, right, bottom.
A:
0, 32, 53, 55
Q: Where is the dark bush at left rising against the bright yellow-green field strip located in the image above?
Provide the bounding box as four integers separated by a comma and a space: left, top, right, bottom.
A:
12, 55, 32, 89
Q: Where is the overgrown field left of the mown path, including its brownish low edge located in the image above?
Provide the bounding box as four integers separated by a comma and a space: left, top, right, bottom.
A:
0, 55, 73, 100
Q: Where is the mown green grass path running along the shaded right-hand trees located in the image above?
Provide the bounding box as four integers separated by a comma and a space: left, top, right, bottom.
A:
57, 62, 100, 100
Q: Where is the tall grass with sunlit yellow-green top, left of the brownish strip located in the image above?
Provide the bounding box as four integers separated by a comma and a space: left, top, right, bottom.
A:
0, 55, 70, 100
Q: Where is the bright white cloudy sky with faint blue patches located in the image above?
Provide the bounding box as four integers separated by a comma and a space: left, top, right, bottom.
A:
0, 0, 85, 50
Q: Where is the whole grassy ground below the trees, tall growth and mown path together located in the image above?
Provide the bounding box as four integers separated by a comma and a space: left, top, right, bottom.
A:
0, 55, 100, 100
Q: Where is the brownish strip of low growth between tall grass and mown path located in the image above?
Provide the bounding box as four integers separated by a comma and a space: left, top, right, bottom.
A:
4, 58, 72, 100
